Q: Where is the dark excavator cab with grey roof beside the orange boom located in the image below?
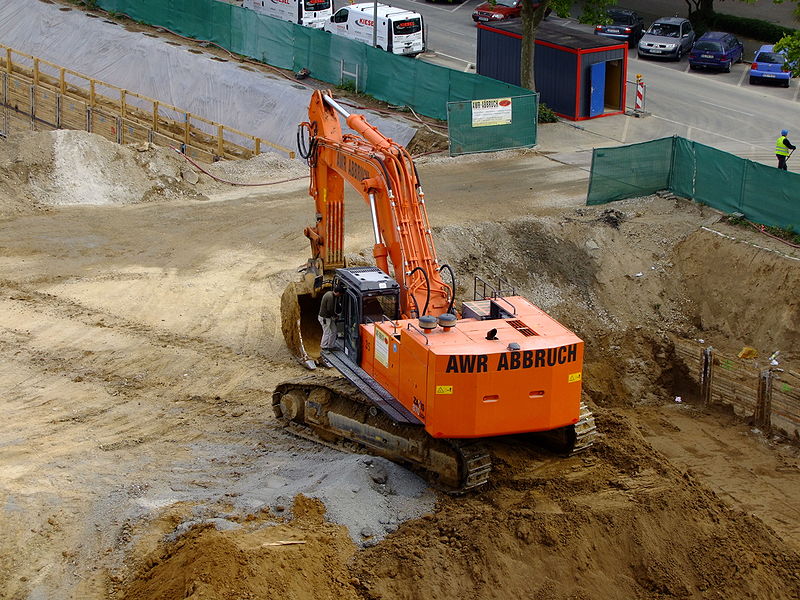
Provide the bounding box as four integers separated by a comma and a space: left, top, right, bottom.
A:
333, 267, 400, 365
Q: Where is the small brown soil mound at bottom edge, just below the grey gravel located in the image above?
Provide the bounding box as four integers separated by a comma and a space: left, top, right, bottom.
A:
116, 495, 358, 600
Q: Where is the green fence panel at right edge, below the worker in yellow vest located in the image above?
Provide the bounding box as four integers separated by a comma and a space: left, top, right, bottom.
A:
739, 161, 800, 233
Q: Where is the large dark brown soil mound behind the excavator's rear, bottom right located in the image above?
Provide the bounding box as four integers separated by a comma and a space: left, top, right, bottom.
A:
353, 410, 800, 600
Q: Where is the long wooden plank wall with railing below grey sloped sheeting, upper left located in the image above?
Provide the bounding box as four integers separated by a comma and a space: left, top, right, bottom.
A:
0, 44, 294, 162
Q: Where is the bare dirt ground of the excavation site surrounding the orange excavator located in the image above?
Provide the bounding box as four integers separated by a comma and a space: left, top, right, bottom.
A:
0, 132, 800, 600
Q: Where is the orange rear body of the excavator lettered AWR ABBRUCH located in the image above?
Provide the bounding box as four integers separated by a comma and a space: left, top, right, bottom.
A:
361, 296, 583, 438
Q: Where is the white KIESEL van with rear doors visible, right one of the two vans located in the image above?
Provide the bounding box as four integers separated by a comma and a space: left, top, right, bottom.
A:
325, 2, 425, 56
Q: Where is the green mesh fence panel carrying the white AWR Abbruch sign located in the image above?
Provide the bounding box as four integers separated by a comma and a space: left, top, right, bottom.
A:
447, 93, 539, 156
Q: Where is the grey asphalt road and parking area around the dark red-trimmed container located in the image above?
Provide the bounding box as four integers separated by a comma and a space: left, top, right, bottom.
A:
346, 0, 800, 167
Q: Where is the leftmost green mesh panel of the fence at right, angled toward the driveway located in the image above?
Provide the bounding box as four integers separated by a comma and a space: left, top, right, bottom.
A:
586, 138, 673, 205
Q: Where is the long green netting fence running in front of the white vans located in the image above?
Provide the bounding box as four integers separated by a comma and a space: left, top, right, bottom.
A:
97, 0, 530, 119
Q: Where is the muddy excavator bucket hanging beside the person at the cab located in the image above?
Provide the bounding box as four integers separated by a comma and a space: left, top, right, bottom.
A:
281, 277, 324, 369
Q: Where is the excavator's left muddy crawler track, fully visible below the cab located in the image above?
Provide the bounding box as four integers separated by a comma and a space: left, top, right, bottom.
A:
272, 375, 492, 495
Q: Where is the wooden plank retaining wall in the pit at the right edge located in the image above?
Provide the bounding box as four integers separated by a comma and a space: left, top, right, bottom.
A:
672, 337, 800, 441
